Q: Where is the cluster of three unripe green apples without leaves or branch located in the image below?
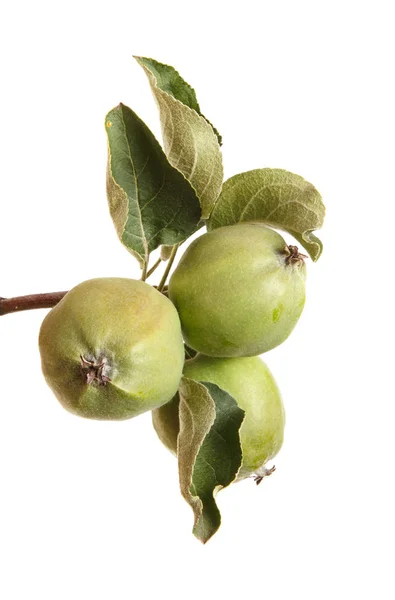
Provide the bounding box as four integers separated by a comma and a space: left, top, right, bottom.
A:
39, 223, 305, 482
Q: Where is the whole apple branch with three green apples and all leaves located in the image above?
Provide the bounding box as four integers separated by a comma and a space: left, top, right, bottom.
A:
0, 56, 325, 543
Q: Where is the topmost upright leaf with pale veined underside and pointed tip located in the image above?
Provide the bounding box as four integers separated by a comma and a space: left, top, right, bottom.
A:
135, 57, 223, 219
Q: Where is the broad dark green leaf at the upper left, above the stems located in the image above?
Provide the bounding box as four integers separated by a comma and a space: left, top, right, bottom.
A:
106, 104, 200, 269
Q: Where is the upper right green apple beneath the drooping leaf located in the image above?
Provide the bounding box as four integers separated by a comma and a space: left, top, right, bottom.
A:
169, 223, 306, 357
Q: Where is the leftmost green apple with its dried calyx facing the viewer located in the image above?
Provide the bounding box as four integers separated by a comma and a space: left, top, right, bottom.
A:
39, 278, 184, 420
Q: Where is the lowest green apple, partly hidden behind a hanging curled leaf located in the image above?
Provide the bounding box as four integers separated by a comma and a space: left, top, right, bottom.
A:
152, 354, 285, 479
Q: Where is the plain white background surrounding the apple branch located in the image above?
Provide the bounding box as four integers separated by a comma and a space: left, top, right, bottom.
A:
0, 0, 395, 600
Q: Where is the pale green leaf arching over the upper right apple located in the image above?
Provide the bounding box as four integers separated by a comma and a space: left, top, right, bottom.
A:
207, 169, 325, 261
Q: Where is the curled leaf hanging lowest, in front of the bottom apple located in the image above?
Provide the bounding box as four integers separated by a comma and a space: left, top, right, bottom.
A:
177, 377, 244, 543
